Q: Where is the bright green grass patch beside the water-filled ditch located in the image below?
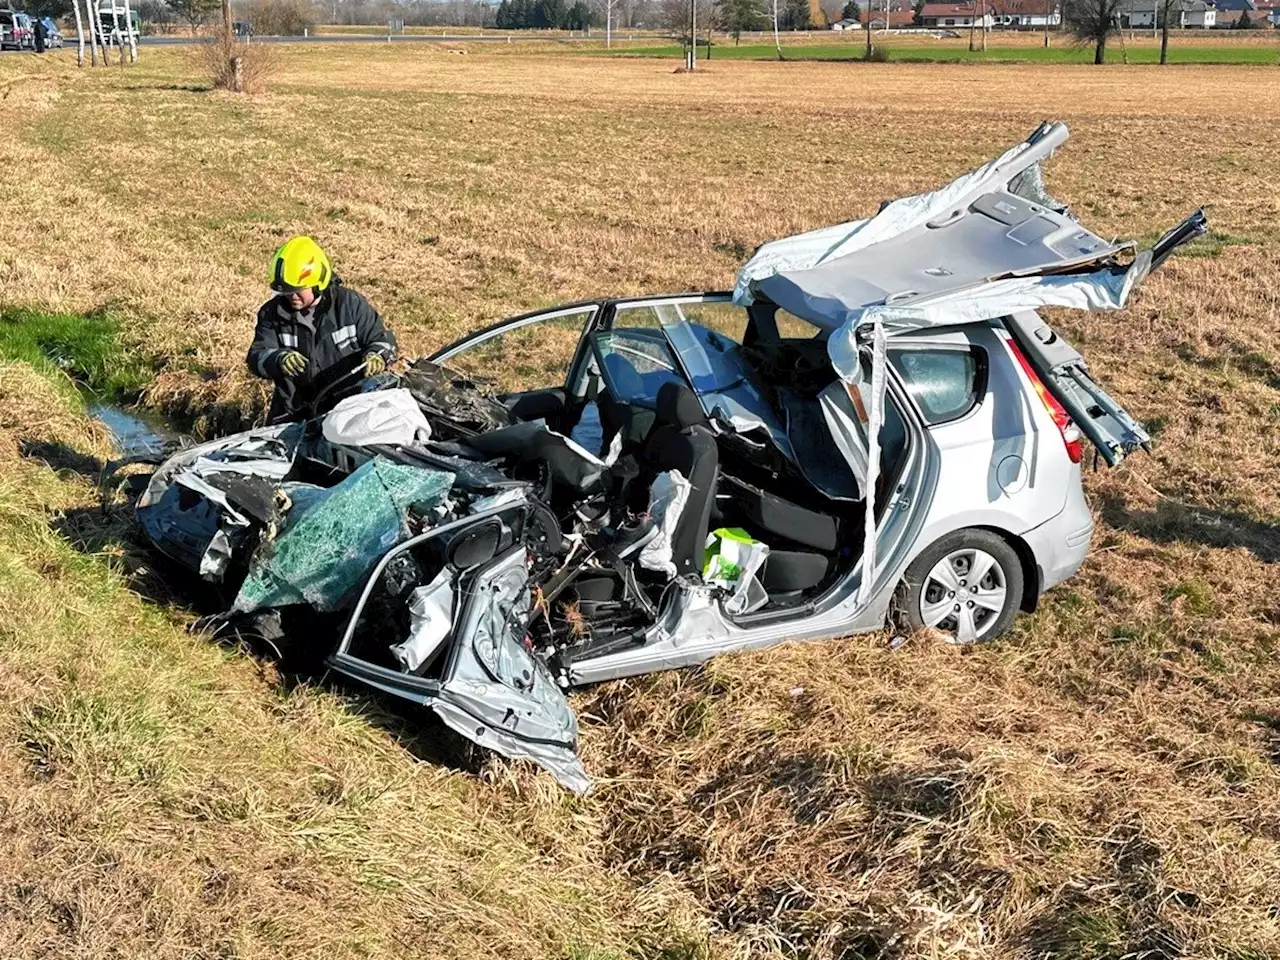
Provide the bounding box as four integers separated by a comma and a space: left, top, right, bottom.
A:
0, 310, 155, 402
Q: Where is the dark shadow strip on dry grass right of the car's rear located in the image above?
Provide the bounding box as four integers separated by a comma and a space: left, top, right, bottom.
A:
1098, 494, 1280, 563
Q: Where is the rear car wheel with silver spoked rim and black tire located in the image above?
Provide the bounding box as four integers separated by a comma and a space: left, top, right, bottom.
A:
895, 529, 1025, 644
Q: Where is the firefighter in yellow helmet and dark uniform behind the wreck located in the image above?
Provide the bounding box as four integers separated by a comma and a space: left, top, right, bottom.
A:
248, 237, 396, 424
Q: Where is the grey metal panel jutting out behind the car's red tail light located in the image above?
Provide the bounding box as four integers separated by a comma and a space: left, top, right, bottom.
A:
1005, 311, 1151, 467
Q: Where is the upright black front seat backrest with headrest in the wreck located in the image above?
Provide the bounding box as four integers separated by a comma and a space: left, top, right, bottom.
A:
632, 383, 719, 575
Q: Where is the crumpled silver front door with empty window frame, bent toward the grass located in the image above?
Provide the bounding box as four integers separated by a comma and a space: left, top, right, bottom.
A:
326, 503, 590, 792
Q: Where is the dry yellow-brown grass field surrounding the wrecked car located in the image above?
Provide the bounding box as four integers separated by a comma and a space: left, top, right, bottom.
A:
0, 46, 1280, 960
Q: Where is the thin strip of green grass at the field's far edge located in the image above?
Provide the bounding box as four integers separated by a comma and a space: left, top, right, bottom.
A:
594, 40, 1280, 65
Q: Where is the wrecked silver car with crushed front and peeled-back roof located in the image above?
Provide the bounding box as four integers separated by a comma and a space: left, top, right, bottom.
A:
137, 124, 1206, 791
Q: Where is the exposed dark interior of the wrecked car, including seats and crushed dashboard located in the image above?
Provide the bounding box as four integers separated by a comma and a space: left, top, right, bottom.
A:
295, 303, 909, 677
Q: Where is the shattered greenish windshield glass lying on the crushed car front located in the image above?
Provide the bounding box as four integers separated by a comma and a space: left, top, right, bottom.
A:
233, 458, 453, 613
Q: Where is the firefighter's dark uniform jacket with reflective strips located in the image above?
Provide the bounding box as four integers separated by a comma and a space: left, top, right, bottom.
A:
247, 276, 396, 422
